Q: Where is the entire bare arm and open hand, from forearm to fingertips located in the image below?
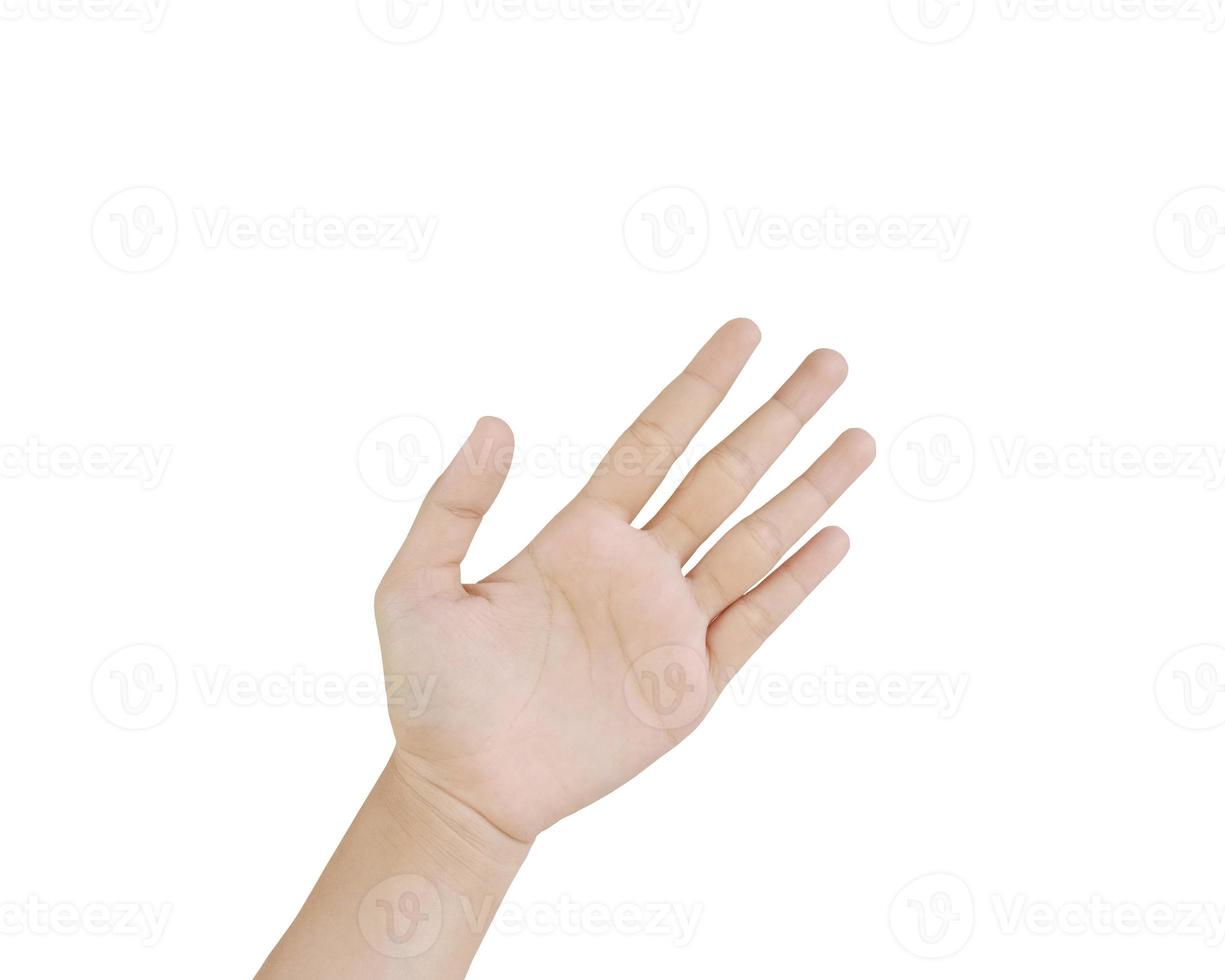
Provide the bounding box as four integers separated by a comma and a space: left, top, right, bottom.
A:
258, 320, 876, 980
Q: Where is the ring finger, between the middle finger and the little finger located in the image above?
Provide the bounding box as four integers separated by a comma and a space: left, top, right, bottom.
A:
690, 429, 876, 619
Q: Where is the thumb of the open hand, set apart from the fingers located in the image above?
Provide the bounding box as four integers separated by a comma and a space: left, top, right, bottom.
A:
387, 418, 515, 597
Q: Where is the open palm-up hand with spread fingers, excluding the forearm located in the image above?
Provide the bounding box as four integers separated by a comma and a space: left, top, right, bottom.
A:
376, 320, 875, 842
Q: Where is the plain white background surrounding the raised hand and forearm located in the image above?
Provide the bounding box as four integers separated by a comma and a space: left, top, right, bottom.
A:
0, 0, 1225, 980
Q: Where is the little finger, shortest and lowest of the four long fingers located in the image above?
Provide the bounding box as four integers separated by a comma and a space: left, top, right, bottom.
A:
706, 528, 850, 690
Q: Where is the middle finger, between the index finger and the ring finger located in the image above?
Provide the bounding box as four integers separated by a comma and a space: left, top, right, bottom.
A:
647, 350, 846, 565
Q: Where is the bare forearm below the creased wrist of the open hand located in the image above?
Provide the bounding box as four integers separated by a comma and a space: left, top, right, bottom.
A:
258, 758, 529, 980
